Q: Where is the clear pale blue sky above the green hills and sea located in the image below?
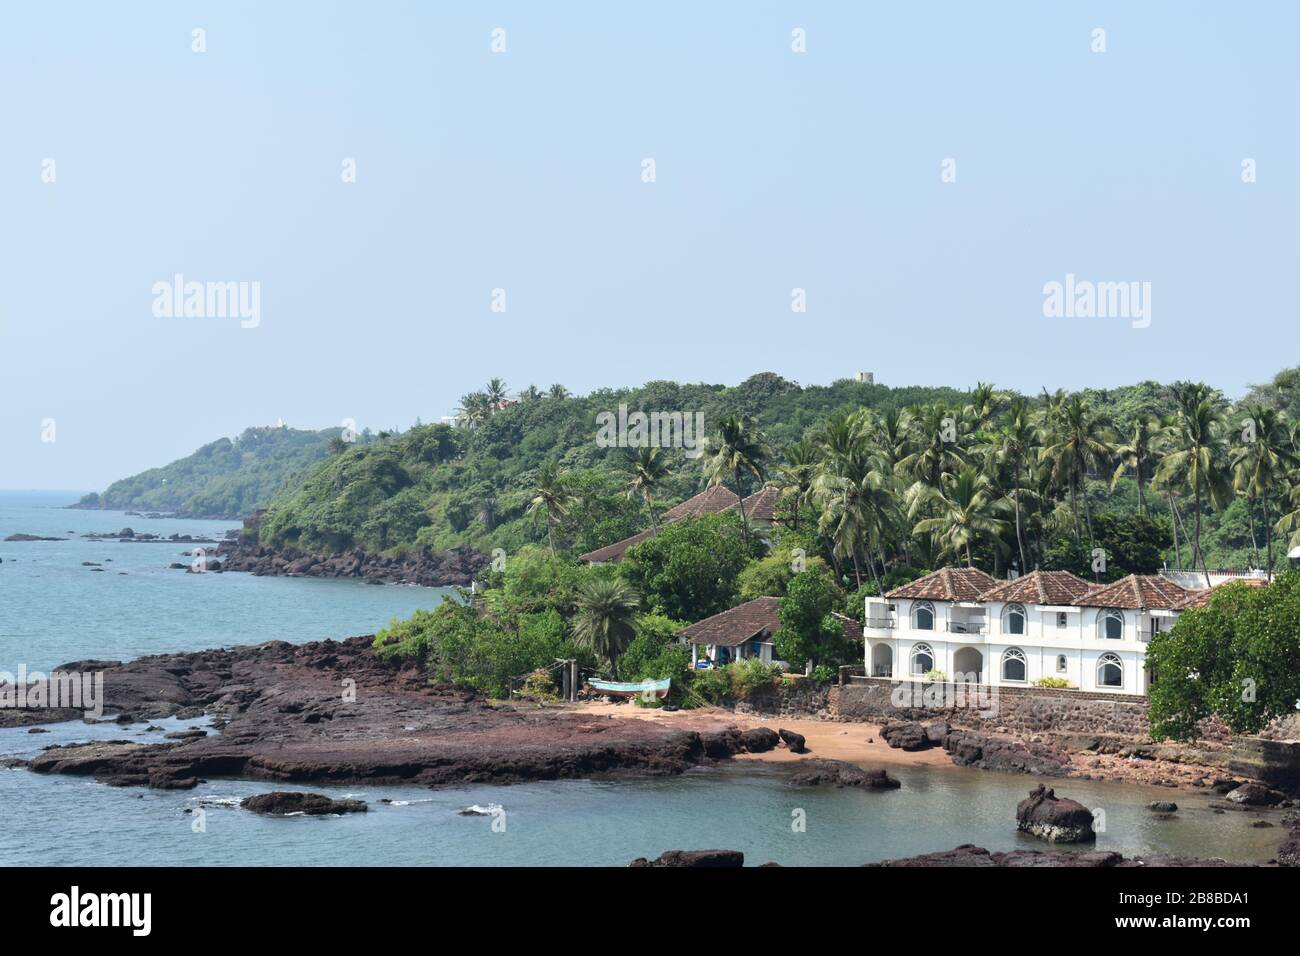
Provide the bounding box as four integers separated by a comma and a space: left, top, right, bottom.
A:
0, 0, 1300, 489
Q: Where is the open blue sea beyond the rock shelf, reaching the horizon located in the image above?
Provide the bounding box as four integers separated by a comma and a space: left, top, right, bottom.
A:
0, 492, 451, 672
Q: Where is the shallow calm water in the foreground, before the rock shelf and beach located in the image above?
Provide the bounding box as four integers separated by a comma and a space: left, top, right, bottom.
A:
0, 721, 1283, 866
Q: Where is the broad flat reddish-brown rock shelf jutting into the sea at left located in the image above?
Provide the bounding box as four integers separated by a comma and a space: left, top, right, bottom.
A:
0, 637, 800, 790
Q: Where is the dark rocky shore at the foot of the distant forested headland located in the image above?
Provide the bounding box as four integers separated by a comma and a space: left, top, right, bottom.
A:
216, 541, 489, 588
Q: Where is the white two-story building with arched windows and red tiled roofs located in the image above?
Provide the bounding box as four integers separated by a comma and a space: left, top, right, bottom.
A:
863, 568, 1196, 695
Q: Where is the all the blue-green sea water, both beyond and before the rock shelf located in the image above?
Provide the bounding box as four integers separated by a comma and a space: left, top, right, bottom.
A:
0, 494, 1283, 865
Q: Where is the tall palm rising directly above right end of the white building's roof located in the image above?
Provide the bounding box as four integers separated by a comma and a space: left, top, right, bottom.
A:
1152, 384, 1230, 588
